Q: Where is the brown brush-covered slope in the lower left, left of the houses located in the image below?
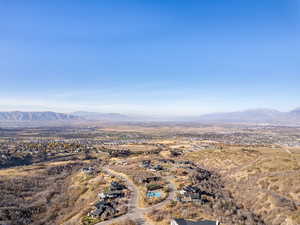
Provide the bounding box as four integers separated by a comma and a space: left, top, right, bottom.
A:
0, 161, 106, 225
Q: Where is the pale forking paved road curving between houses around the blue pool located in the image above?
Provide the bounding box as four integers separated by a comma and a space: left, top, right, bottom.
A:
96, 168, 176, 225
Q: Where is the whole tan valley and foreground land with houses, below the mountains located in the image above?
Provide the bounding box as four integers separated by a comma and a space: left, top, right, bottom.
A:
0, 123, 300, 225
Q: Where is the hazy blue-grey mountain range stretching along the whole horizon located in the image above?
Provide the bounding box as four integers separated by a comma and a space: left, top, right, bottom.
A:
0, 108, 300, 125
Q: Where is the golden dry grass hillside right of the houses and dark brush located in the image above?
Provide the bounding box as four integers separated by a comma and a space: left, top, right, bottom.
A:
184, 146, 300, 225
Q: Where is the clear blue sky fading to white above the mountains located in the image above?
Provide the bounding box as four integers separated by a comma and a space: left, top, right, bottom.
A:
0, 0, 300, 115
